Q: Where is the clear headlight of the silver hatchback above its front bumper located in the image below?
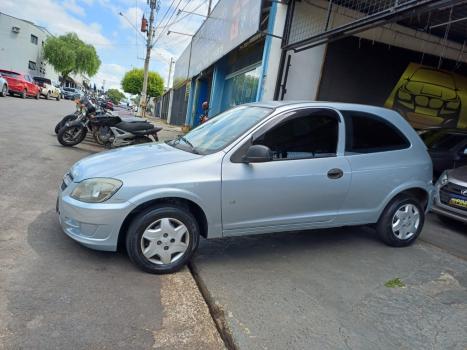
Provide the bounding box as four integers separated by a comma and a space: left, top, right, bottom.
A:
70, 178, 123, 203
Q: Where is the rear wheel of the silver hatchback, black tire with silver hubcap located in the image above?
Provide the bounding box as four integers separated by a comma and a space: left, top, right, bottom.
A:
376, 195, 425, 247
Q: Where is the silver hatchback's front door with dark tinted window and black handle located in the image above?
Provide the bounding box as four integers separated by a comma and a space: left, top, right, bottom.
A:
221, 108, 350, 236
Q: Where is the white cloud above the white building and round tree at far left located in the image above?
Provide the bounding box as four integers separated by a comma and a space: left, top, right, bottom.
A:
2, 0, 111, 46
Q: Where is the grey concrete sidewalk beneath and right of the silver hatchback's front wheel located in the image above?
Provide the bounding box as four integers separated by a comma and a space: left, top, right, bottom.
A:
193, 228, 467, 350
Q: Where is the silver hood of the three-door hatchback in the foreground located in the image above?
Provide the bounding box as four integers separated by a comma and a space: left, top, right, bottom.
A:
70, 143, 202, 182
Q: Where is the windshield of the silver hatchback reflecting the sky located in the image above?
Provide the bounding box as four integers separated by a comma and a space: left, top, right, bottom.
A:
168, 106, 272, 154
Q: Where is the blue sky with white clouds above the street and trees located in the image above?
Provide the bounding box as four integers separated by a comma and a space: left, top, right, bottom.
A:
0, 0, 217, 89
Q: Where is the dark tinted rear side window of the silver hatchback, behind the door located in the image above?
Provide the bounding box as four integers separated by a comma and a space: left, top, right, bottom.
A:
342, 111, 410, 154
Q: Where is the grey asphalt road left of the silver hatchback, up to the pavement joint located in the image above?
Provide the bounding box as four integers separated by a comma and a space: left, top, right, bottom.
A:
0, 97, 222, 349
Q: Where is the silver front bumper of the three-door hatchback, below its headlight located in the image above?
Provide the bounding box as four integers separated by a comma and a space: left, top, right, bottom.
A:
56, 190, 134, 251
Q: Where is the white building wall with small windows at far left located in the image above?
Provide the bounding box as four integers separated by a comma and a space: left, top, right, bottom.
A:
0, 13, 58, 81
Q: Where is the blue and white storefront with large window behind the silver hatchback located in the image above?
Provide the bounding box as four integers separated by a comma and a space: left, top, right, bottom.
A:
171, 0, 283, 126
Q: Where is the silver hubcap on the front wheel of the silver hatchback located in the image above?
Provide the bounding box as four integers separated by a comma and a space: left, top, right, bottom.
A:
141, 218, 190, 265
